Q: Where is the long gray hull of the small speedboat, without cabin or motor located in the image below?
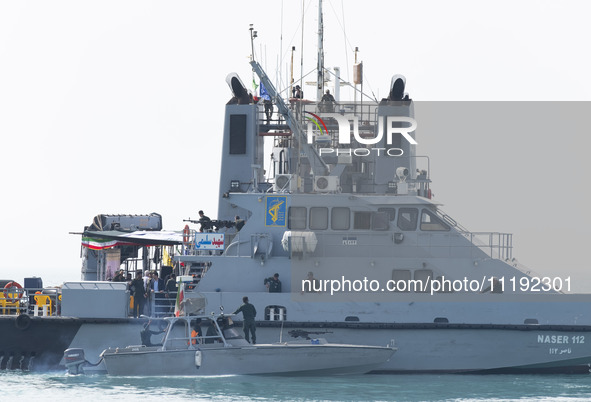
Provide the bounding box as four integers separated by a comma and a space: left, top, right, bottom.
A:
103, 344, 395, 376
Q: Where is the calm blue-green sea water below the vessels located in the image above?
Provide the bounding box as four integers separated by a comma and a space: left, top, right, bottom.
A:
0, 371, 591, 402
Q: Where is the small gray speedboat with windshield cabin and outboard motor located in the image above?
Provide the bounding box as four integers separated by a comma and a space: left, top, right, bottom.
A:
64, 315, 396, 376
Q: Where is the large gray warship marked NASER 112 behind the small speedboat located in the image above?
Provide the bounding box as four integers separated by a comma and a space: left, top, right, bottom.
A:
0, 0, 591, 373
